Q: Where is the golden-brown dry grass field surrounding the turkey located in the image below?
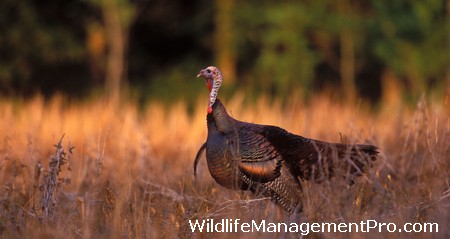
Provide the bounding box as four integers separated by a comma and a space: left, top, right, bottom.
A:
0, 94, 450, 239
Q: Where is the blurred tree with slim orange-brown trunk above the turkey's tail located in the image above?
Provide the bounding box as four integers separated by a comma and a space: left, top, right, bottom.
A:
304, 0, 368, 102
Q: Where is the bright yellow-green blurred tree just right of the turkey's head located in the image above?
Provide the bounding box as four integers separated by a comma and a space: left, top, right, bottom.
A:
236, 1, 318, 96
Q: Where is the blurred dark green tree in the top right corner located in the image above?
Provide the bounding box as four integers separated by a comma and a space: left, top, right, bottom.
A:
371, 0, 450, 98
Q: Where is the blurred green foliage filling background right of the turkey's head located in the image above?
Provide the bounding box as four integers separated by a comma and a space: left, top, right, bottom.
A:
235, 0, 450, 100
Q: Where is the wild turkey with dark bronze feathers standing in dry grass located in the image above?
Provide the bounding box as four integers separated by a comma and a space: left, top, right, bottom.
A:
194, 66, 378, 213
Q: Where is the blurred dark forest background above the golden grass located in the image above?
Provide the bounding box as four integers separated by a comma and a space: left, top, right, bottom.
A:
0, 0, 450, 102
